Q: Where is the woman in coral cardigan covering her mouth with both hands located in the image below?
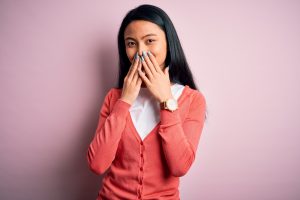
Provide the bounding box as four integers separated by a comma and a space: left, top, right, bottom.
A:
87, 5, 206, 200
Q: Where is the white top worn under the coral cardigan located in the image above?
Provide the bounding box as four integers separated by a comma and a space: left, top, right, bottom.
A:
129, 83, 184, 140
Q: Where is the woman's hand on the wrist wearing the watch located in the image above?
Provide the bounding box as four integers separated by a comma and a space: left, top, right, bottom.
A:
138, 51, 172, 102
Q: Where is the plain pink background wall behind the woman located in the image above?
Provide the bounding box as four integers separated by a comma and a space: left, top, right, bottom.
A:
0, 0, 300, 200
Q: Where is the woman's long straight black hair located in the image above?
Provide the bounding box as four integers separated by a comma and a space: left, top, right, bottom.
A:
118, 4, 197, 89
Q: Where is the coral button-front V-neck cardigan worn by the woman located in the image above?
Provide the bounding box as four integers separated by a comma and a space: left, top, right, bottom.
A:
87, 85, 206, 200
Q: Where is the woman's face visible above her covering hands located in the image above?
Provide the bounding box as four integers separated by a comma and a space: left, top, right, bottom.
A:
124, 20, 167, 69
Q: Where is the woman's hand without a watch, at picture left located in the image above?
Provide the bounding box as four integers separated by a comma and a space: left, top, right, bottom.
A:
120, 54, 142, 104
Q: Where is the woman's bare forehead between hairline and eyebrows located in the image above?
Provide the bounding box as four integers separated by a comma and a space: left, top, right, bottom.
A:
124, 20, 165, 38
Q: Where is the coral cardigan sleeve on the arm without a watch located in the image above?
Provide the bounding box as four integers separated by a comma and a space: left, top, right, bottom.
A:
86, 89, 131, 175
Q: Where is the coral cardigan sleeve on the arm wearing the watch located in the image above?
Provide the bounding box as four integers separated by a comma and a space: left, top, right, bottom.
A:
159, 92, 206, 177
